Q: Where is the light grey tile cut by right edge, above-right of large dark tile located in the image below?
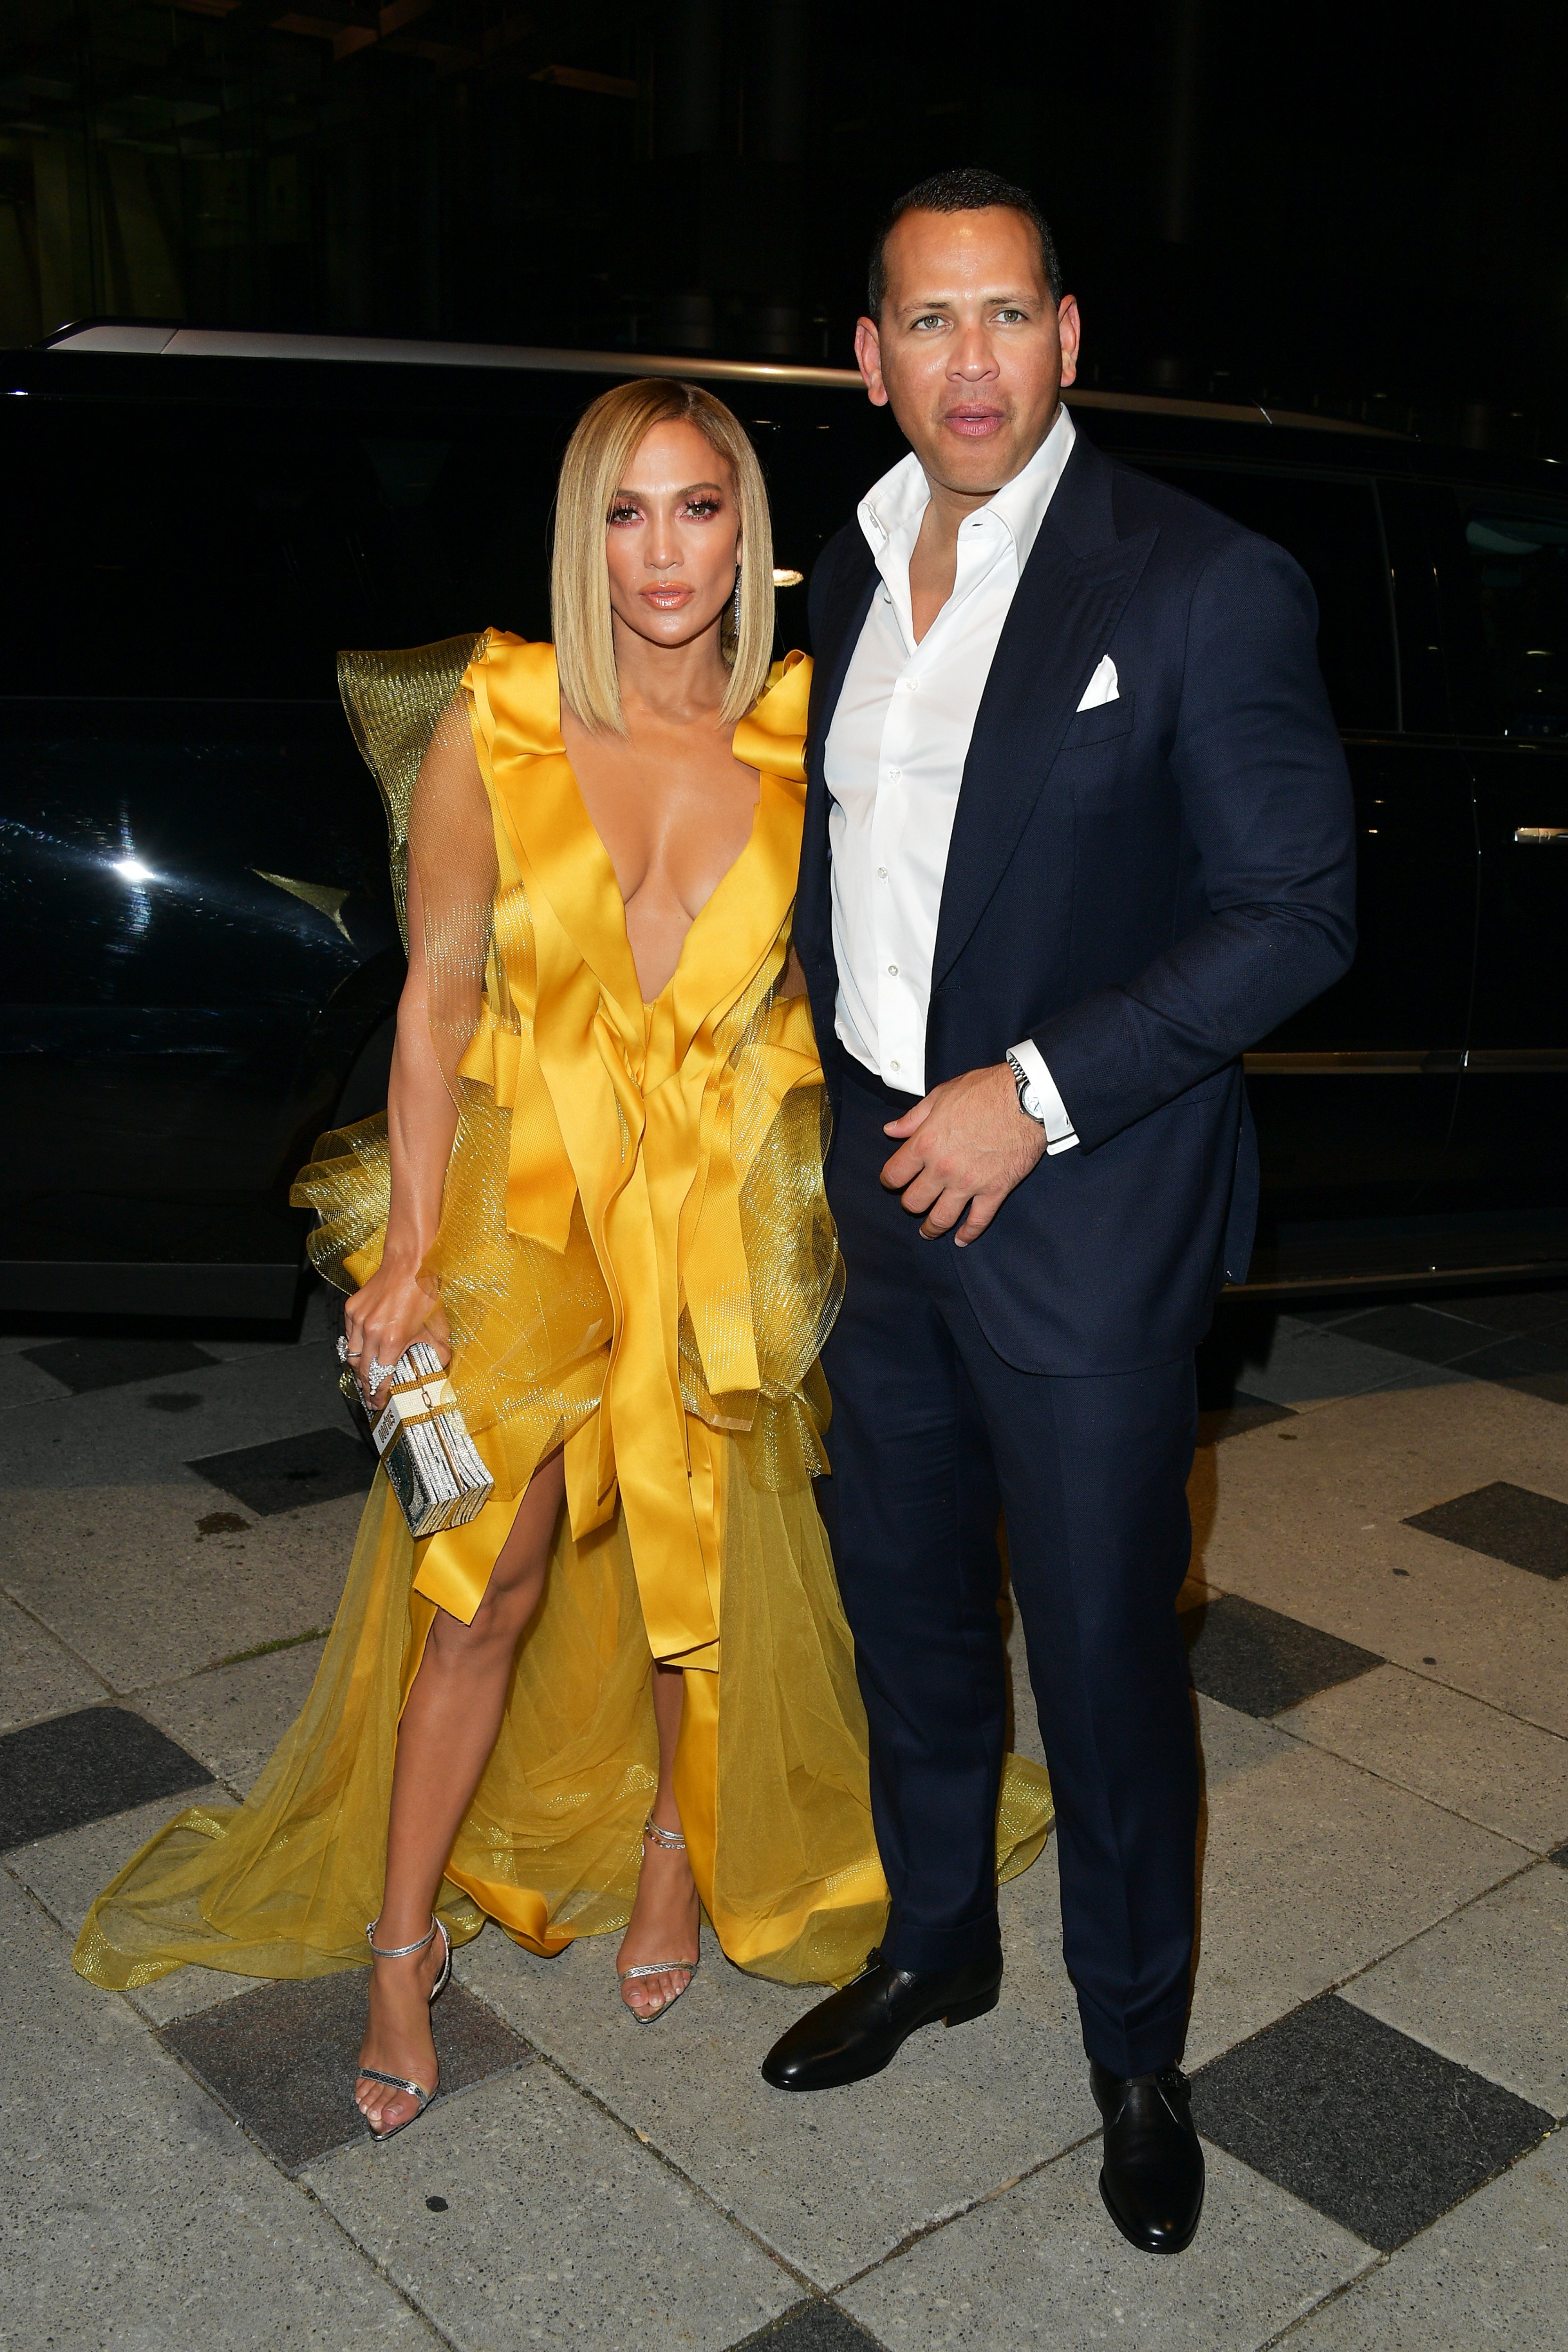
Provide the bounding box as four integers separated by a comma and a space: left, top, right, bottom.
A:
1342, 1863, 1568, 2122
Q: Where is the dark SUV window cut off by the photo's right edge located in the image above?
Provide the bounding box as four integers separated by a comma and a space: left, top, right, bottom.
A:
1460, 492, 1568, 743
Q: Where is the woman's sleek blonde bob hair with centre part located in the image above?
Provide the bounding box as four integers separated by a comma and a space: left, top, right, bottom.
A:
550, 376, 773, 734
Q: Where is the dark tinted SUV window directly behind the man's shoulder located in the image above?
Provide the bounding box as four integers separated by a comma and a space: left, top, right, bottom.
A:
1136, 459, 1399, 729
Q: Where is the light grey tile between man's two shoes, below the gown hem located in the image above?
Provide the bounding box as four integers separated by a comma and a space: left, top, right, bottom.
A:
458, 1846, 1098, 2286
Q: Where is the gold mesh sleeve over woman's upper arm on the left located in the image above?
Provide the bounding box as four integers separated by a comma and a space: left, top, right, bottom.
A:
339, 633, 496, 1105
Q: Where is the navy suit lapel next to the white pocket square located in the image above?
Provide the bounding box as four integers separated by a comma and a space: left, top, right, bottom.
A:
931, 437, 1157, 993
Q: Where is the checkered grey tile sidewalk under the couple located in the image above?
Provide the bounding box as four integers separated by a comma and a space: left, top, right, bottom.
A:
0, 1289, 1568, 2352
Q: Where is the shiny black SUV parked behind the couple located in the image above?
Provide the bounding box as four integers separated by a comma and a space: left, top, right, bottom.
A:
0, 325, 1568, 1317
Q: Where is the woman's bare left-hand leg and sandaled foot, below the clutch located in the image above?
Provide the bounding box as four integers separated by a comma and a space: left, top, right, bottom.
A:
355, 1454, 566, 2131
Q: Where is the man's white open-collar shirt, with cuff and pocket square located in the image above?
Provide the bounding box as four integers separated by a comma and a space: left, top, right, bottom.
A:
823, 407, 1086, 1152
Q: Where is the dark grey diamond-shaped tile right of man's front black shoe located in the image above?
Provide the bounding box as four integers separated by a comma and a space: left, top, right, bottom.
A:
1192, 1992, 1552, 2253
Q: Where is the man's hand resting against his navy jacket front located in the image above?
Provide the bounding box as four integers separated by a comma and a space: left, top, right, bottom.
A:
882, 1061, 1046, 1249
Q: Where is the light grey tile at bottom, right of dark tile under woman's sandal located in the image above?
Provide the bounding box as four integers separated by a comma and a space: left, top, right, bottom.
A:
306, 2065, 799, 2352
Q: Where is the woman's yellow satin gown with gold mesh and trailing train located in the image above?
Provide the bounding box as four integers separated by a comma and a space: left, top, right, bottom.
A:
75, 630, 1051, 1987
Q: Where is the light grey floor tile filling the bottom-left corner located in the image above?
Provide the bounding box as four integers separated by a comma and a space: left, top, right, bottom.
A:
0, 1879, 437, 2352
